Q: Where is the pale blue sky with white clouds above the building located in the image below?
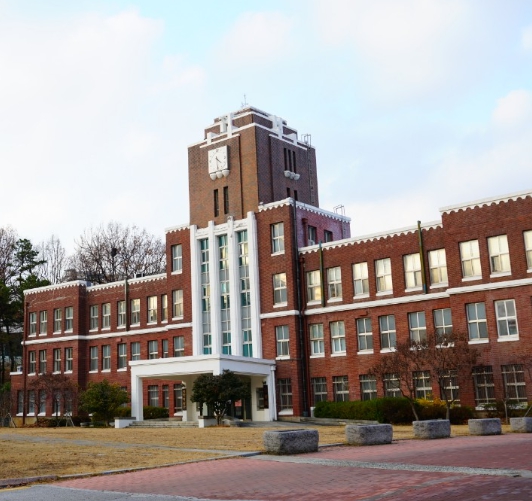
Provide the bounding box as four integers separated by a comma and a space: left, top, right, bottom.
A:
0, 0, 532, 252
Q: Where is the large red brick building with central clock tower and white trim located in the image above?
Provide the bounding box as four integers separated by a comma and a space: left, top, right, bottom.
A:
11, 107, 532, 421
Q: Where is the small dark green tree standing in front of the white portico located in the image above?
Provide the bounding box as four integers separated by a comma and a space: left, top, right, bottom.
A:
191, 370, 250, 425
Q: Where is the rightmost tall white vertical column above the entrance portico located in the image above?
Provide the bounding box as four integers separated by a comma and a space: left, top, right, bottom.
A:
247, 211, 262, 358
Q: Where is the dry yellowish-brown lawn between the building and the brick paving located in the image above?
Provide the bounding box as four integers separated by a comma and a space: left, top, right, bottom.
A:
0, 426, 509, 479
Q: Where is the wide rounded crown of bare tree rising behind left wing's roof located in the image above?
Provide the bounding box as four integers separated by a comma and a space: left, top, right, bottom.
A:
69, 222, 166, 284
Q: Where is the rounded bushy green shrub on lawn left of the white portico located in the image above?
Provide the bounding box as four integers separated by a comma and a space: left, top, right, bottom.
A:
80, 379, 129, 426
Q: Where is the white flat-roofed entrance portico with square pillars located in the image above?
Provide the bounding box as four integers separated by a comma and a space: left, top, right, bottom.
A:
129, 355, 277, 421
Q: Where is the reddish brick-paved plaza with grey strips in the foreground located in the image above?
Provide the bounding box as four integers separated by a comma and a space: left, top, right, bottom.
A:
0, 434, 532, 501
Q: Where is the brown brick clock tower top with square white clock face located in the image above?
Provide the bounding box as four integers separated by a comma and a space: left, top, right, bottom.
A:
188, 106, 319, 228
